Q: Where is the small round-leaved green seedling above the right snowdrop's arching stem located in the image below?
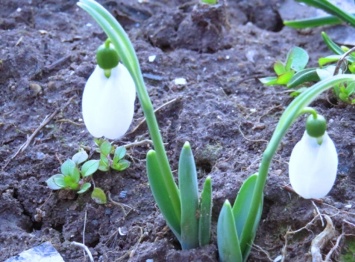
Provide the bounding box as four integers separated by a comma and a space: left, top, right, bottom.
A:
259, 47, 309, 86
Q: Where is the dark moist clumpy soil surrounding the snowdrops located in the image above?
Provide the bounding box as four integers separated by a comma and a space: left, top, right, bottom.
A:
0, 0, 355, 262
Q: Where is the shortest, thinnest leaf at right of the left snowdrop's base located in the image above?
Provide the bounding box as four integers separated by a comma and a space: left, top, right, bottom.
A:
198, 176, 212, 247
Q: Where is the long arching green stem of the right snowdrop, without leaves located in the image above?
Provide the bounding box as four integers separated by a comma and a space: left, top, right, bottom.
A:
240, 74, 355, 250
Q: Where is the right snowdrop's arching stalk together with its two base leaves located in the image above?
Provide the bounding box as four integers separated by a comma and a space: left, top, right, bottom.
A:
217, 74, 355, 262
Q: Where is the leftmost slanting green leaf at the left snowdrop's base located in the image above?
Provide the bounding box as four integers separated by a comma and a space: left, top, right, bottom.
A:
147, 150, 181, 242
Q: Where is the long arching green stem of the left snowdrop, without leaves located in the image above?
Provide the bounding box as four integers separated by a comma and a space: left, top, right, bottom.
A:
78, 0, 180, 217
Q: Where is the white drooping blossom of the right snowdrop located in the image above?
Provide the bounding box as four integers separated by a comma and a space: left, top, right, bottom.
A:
289, 131, 338, 199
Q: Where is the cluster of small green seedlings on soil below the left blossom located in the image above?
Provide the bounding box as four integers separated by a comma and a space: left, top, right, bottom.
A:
46, 139, 130, 204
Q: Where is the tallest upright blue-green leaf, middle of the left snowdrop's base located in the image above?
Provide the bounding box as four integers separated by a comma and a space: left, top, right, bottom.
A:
178, 142, 199, 249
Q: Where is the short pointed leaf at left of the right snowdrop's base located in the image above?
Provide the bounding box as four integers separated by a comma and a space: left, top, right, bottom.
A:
217, 200, 243, 262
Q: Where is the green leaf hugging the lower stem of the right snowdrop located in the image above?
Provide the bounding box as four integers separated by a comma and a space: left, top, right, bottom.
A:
233, 174, 263, 260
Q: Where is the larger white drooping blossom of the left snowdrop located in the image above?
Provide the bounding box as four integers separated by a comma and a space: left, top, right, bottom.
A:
82, 63, 136, 139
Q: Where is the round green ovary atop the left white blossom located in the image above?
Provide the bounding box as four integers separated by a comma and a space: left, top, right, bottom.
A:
96, 41, 120, 70
